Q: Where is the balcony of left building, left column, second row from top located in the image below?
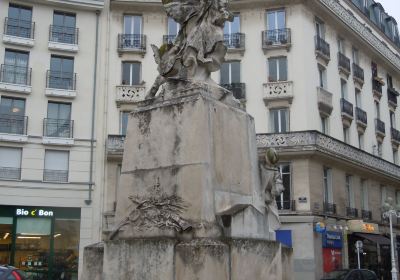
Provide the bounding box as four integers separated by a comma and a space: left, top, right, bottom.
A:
0, 64, 32, 94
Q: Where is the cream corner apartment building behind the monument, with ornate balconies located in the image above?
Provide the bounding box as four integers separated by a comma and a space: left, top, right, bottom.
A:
101, 0, 400, 279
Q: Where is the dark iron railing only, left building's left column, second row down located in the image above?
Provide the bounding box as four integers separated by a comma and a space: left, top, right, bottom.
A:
0, 64, 32, 86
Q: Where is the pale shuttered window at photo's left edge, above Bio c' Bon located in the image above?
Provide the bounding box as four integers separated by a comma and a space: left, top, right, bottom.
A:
0, 147, 22, 180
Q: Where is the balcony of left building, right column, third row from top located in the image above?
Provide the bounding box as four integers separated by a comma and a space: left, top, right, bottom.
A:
42, 118, 74, 146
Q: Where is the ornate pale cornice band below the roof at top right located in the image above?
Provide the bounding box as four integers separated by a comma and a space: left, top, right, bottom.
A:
318, 0, 400, 71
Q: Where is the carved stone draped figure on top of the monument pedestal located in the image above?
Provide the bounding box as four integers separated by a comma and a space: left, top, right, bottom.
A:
146, 0, 233, 98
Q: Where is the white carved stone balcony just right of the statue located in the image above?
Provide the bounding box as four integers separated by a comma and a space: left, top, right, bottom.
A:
264, 81, 293, 107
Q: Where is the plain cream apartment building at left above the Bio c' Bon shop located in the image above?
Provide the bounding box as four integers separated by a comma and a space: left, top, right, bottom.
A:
0, 0, 104, 279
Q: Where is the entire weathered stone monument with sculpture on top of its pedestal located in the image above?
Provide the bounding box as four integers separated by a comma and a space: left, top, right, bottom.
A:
82, 0, 291, 280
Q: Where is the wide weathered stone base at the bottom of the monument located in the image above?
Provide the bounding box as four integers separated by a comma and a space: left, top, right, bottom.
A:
81, 239, 292, 280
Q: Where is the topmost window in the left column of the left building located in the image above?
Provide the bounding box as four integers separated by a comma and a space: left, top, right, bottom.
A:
6, 4, 33, 38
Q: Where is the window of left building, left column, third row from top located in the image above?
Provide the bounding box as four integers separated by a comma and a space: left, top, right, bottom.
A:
0, 96, 26, 134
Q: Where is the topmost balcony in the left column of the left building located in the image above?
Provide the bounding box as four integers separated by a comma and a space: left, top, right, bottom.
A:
3, 18, 35, 47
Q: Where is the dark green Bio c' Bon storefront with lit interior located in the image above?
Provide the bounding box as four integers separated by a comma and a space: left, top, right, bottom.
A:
0, 206, 81, 280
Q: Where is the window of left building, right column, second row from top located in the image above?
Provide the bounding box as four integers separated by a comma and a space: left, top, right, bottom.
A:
47, 55, 75, 90
